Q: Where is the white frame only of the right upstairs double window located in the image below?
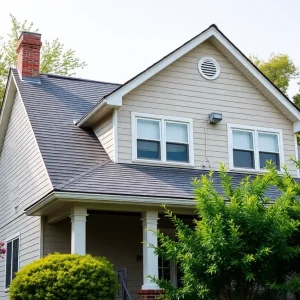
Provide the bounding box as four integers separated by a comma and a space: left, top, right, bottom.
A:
227, 123, 285, 172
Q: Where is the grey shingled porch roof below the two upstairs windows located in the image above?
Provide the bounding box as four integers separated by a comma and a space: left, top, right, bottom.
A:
56, 160, 286, 200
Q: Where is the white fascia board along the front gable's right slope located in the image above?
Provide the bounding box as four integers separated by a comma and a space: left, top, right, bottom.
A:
212, 28, 300, 120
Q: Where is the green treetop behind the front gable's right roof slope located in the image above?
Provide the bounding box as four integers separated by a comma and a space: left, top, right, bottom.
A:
250, 53, 299, 94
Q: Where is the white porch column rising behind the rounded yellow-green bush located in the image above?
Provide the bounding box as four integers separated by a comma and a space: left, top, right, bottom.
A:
70, 205, 88, 255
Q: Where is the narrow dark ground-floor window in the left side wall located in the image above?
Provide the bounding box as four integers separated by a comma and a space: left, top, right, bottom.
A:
5, 234, 20, 289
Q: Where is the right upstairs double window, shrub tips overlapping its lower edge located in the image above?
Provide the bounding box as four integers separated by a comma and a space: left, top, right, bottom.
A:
228, 124, 283, 170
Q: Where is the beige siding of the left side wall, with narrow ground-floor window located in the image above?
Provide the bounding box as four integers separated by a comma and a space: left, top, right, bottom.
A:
0, 94, 52, 300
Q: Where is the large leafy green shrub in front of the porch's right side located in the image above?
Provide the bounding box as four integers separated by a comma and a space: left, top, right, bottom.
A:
150, 165, 300, 300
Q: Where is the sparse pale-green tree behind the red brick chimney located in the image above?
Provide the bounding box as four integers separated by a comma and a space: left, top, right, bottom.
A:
0, 15, 86, 100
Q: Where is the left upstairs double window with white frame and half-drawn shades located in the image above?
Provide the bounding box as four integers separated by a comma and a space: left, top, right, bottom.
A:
132, 113, 193, 165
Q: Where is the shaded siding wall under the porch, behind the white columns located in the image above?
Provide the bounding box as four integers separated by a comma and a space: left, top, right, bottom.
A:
43, 214, 143, 299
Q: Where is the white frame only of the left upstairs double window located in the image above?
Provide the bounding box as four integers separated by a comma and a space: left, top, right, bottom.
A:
131, 112, 194, 167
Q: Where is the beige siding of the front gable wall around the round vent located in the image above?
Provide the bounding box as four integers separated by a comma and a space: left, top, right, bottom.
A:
118, 42, 297, 176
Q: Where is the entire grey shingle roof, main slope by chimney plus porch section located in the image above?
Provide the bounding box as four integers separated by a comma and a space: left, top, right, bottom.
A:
13, 70, 296, 199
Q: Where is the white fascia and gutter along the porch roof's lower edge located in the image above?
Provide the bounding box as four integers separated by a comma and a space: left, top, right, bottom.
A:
26, 192, 195, 216
